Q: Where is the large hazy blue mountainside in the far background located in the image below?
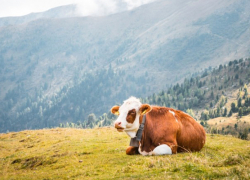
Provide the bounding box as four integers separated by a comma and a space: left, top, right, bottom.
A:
0, 0, 250, 131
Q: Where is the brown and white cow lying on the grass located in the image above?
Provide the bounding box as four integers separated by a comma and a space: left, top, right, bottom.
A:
111, 97, 206, 155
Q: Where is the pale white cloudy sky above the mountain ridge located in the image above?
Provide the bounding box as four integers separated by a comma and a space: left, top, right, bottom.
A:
0, 0, 155, 17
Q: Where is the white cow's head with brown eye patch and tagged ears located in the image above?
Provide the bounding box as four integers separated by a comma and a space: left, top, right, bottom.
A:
111, 97, 152, 138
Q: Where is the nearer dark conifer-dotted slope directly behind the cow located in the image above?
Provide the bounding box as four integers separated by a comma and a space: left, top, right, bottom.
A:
63, 58, 250, 139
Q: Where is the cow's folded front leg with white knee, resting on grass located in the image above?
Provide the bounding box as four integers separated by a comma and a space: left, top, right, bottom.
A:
152, 143, 177, 156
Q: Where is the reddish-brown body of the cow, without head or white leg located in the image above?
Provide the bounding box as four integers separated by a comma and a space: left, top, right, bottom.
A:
140, 106, 206, 154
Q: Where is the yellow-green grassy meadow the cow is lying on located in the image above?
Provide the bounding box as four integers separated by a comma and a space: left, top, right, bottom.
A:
0, 128, 250, 180
